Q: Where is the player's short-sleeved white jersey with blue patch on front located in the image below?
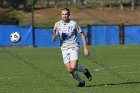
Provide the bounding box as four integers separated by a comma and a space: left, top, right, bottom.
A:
55, 20, 82, 49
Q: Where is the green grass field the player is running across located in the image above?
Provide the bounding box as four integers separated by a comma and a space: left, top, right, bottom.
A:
0, 45, 140, 93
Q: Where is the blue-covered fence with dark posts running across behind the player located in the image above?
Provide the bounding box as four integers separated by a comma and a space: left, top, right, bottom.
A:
0, 25, 140, 47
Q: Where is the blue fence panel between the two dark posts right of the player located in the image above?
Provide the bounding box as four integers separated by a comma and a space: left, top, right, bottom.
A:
91, 26, 120, 45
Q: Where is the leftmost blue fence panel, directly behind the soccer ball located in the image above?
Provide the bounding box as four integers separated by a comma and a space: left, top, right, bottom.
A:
0, 26, 33, 46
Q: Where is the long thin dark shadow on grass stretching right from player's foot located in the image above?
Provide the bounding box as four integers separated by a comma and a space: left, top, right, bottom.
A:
86, 81, 140, 87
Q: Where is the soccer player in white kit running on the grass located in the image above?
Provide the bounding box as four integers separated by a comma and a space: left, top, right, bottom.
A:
52, 8, 92, 87
